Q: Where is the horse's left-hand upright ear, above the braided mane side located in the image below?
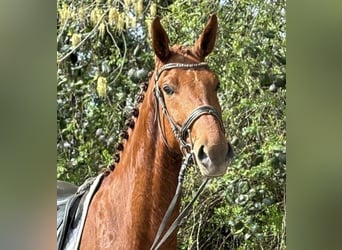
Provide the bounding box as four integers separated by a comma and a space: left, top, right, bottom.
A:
151, 17, 170, 62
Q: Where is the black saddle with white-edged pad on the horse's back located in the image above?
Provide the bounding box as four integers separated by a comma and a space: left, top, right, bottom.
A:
57, 174, 103, 250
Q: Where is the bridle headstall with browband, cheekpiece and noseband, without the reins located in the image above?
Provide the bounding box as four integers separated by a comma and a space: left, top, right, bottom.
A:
154, 62, 224, 154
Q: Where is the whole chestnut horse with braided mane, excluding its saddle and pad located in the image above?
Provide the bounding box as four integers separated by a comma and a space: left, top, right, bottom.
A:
80, 15, 232, 250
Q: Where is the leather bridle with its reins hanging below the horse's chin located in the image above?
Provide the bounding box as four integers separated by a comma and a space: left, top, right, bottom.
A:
150, 62, 224, 250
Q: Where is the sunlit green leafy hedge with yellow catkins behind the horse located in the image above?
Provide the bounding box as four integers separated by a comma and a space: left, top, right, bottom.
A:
57, 0, 286, 249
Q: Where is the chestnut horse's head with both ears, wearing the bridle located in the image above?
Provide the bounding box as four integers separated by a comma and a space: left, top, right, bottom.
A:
151, 15, 233, 177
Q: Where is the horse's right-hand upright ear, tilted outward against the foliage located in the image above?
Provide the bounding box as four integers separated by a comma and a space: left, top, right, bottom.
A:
194, 14, 218, 58
